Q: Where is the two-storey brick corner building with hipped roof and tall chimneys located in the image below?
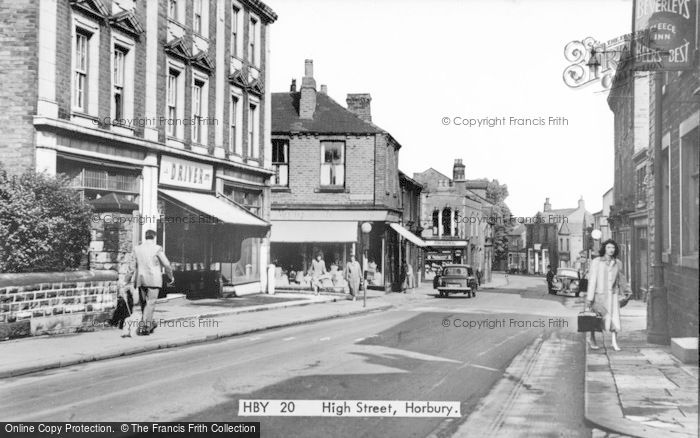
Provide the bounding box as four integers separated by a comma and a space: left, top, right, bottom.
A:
270, 60, 418, 290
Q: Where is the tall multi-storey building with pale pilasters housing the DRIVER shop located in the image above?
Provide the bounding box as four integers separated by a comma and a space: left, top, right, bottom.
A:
0, 0, 277, 294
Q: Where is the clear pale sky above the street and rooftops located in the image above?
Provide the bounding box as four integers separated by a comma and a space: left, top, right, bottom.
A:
266, 0, 632, 216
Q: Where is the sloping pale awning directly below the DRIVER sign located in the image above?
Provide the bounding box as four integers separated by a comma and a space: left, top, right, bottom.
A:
158, 189, 270, 228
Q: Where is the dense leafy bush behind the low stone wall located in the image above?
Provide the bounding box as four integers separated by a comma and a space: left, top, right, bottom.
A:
0, 169, 92, 272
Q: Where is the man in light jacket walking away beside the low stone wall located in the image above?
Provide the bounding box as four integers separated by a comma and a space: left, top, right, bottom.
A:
127, 230, 175, 335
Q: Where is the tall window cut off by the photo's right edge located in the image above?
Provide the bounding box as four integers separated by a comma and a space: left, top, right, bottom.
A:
680, 128, 700, 255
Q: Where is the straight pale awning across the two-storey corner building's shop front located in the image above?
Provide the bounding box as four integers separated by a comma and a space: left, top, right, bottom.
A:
270, 221, 357, 243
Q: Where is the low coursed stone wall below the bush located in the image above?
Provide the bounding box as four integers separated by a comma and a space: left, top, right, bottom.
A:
0, 271, 118, 340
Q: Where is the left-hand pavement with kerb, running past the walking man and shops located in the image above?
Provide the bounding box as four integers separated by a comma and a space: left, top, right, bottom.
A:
0, 292, 393, 378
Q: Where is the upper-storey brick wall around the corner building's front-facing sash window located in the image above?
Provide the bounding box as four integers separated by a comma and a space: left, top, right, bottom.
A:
272, 135, 378, 205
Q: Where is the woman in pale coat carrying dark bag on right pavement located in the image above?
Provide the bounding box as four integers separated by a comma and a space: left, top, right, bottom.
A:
586, 239, 631, 351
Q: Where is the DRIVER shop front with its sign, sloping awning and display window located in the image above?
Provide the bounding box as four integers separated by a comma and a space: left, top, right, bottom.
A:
158, 155, 270, 299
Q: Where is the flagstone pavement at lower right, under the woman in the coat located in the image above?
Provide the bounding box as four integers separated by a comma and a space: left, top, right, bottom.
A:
585, 301, 698, 438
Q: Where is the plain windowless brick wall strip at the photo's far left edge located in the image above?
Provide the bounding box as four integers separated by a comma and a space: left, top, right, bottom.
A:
0, 0, 39, 173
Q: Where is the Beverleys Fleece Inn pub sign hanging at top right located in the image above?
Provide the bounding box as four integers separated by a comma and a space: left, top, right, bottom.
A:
634, 0, 699, 70
